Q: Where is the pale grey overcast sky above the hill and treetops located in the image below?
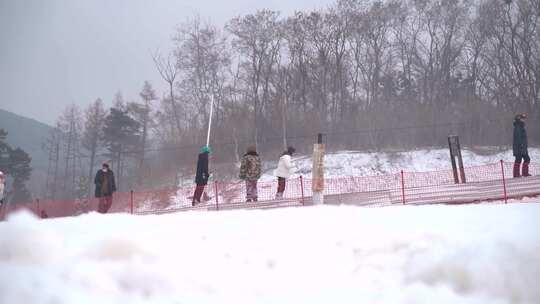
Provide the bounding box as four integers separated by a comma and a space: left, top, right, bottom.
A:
0, 0, 334, 124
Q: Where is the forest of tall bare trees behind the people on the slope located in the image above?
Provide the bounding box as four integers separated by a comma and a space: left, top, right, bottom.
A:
43, 0, 540, 198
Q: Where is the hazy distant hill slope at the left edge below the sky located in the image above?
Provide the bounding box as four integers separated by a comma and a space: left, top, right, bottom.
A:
0, 109, 53, 171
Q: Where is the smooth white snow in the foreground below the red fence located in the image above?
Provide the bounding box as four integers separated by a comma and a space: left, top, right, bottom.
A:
0, 199, 540, 304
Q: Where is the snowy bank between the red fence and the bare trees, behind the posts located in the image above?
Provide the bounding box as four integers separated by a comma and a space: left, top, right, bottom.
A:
261, 148, 540, 181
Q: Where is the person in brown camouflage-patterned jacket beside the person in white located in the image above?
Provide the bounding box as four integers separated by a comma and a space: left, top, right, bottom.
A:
240, 146, 261, 202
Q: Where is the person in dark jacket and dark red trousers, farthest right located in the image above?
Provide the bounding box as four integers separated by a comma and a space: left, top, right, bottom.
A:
512, 114, 531, 177
